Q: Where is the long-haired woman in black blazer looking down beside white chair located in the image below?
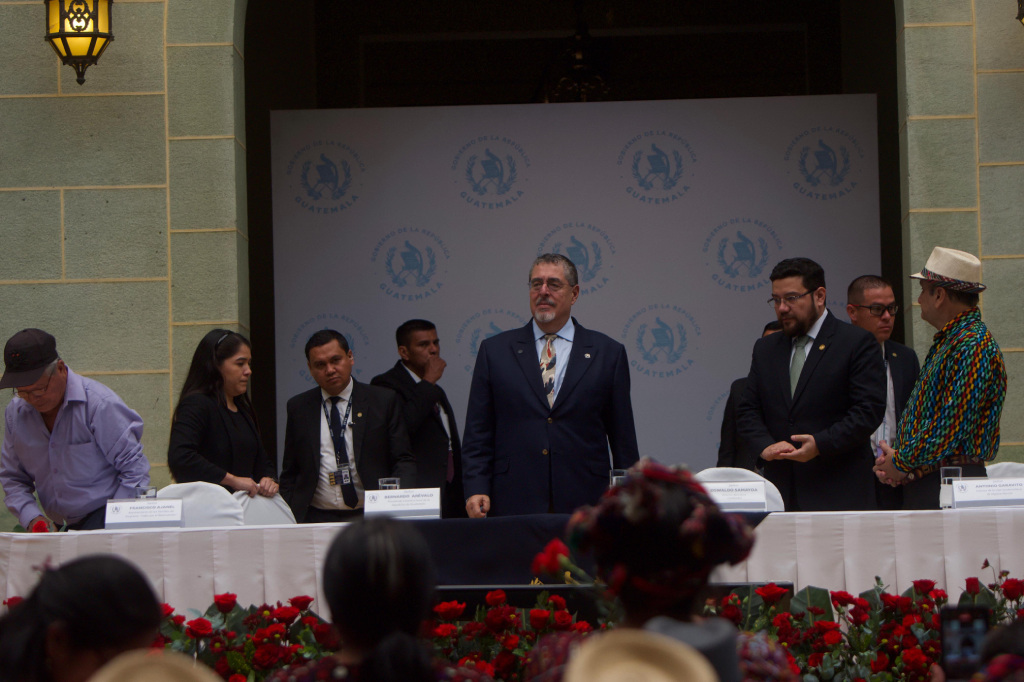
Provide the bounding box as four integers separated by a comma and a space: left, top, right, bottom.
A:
167, 329, 278, 498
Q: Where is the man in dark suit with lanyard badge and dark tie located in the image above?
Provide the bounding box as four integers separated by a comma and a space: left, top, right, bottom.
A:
281, 329, 416, 523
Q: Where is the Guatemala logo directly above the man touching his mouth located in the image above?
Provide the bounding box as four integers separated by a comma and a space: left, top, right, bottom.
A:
370, 227, 452, 301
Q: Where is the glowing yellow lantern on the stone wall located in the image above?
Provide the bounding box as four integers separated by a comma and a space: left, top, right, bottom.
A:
43, 0, 114, 85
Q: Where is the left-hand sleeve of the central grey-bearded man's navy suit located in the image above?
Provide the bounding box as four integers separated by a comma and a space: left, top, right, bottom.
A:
462, 341, 495, 493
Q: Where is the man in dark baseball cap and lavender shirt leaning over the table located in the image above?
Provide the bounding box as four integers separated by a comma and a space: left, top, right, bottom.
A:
0, 329, 150, 530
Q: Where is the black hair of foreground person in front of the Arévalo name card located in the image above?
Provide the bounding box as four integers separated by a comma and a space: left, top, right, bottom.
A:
324, 518, 435, 681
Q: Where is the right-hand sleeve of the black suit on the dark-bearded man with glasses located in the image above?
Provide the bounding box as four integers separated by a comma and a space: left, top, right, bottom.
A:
812, 330, 887, 459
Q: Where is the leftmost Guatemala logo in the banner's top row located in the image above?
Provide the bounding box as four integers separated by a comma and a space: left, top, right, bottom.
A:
285, 139, 367, 213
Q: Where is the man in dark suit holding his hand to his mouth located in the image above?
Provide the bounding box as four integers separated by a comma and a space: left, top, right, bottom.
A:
370, 319, 466, 518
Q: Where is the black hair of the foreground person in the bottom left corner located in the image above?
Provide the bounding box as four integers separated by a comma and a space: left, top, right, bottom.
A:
0, 554, 163, 682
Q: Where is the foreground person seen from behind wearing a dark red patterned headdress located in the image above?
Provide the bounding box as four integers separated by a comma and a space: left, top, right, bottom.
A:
524, 458, 795, 682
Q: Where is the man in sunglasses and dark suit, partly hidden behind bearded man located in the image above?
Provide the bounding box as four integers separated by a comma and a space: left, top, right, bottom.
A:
846, 274, 921, 510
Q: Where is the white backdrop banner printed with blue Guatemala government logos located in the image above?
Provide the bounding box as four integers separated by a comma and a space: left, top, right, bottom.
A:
272, 95, 880, 470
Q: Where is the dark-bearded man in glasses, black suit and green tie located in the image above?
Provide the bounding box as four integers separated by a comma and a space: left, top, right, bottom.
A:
738, 258, 886, 511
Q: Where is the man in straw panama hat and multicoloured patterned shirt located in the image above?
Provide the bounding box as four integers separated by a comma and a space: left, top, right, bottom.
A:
874, 247, 1007, 509
